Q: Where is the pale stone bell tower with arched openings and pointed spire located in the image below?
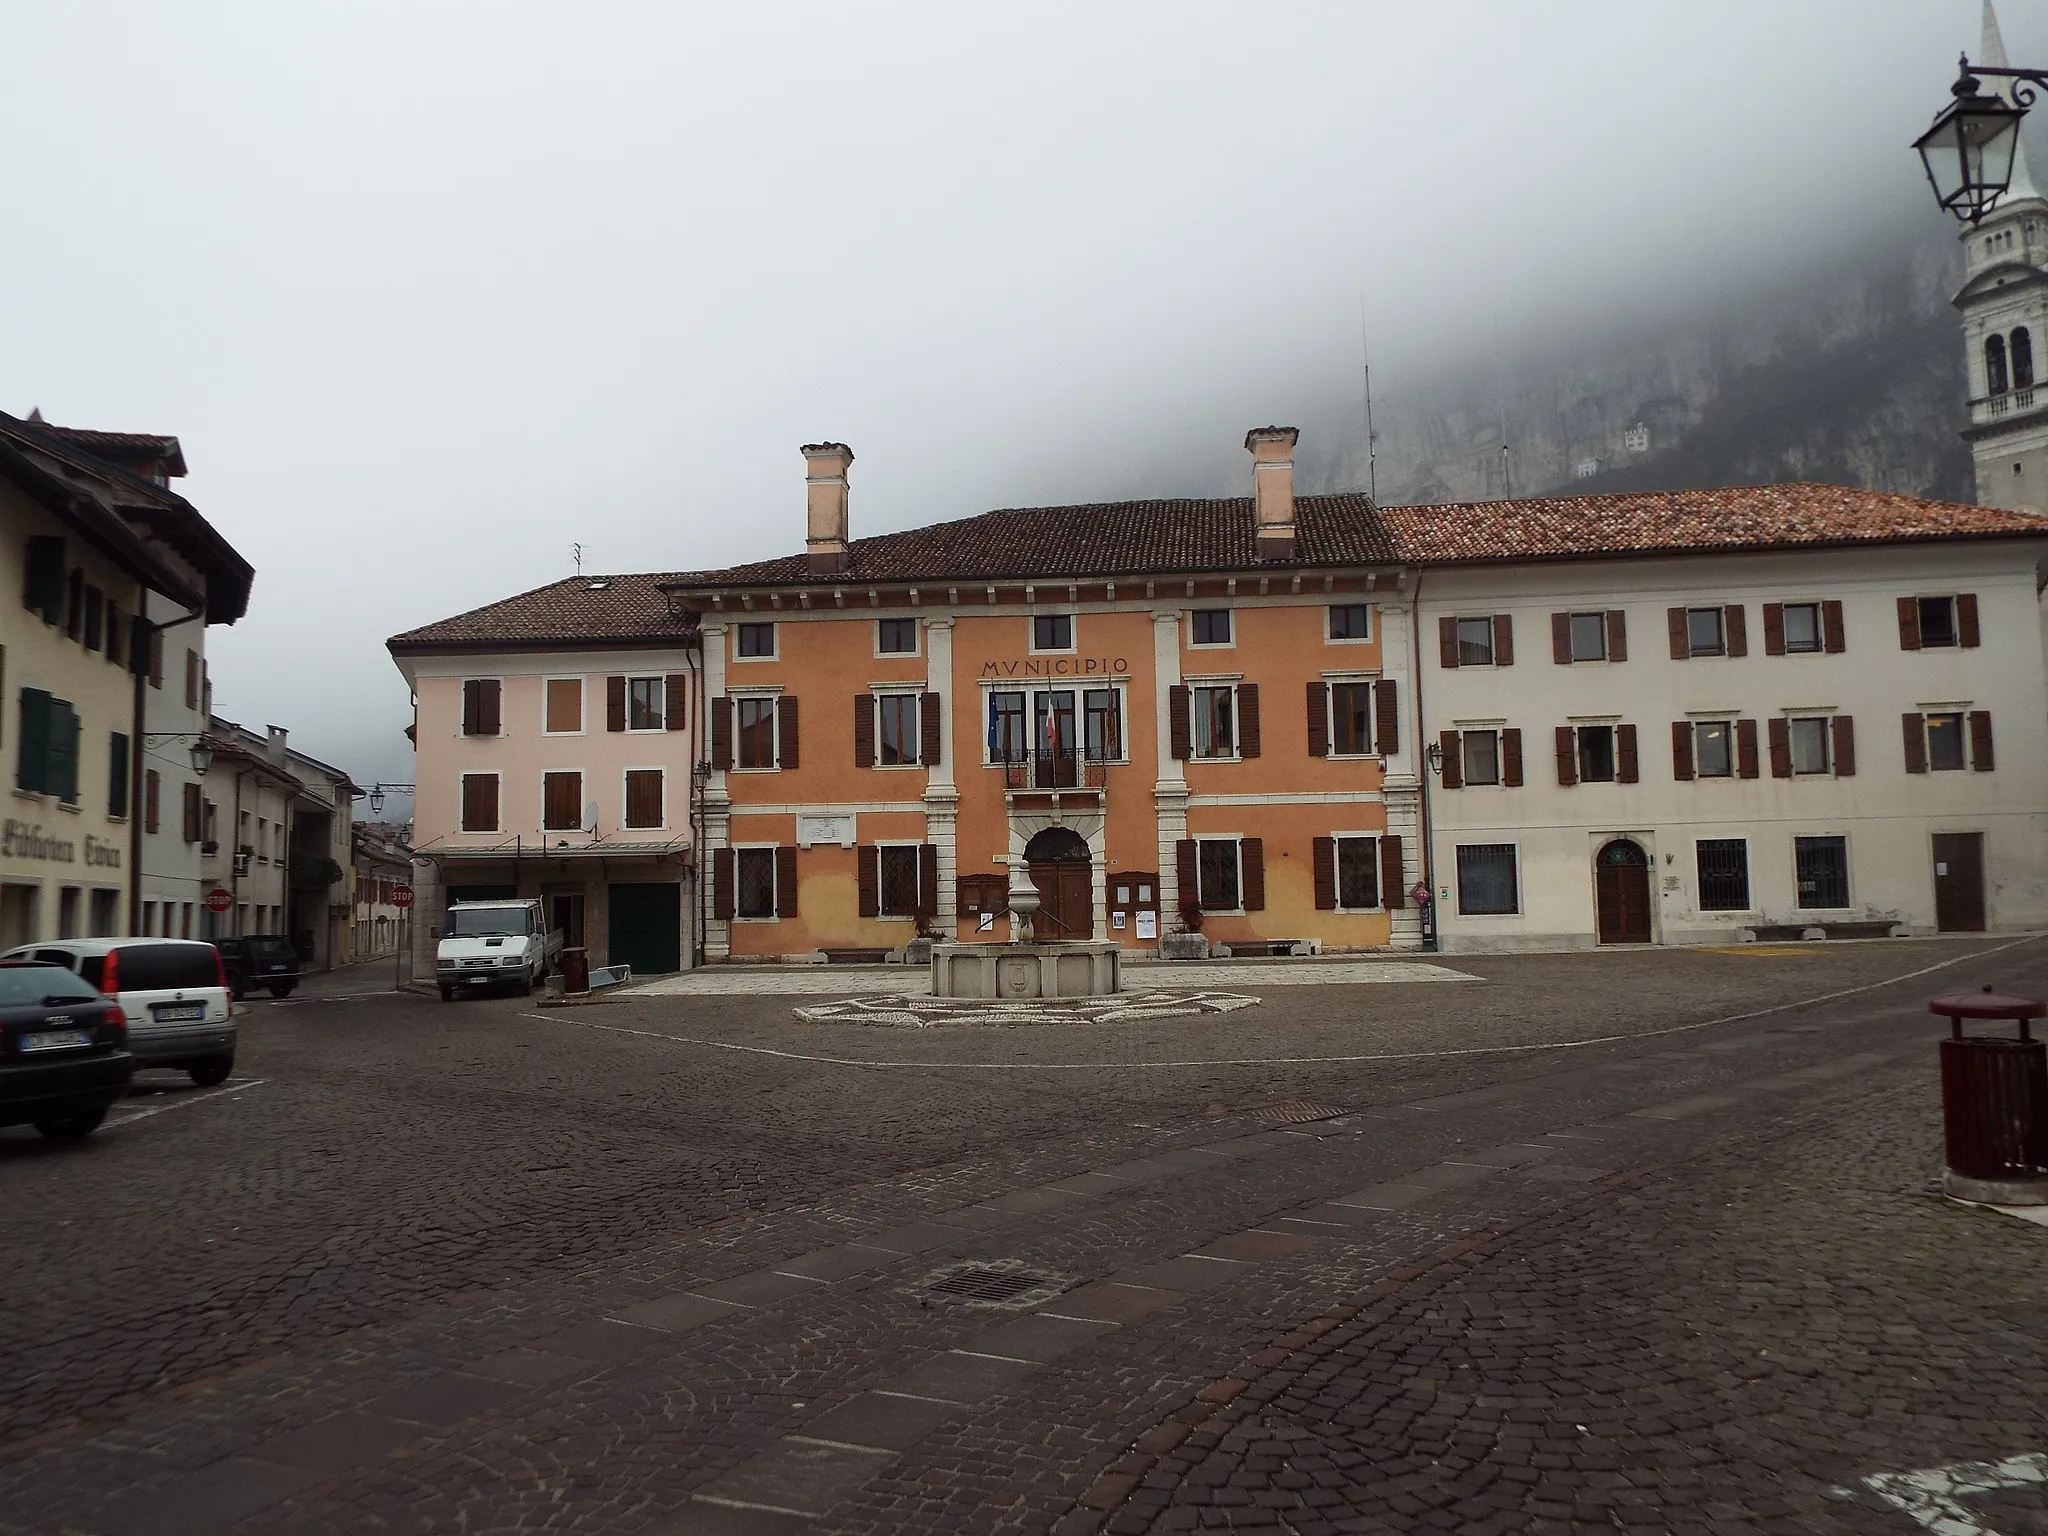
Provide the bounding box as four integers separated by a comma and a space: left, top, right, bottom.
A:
1954, 0, 2048, 512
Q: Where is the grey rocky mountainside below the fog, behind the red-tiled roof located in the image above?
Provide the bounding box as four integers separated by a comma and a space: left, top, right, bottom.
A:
1305, 231, 1972, 506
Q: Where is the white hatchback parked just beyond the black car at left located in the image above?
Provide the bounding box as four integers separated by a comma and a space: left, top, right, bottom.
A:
0, 938, 236, 1087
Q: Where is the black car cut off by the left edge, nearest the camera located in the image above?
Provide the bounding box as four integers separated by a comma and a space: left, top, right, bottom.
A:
0, 961, 135, 1141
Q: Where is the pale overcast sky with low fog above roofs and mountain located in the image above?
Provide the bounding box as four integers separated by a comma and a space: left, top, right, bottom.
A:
0, 0, 2023, 819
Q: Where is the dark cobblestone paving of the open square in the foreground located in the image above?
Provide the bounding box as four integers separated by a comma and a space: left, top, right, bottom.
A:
0, 942, 2048, 1536
